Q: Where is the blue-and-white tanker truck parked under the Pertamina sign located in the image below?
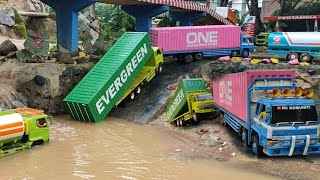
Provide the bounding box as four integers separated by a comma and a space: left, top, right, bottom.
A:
268, 32, 320, 62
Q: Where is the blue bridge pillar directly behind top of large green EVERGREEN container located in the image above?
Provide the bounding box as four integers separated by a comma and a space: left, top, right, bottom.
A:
121, 5, 169, 32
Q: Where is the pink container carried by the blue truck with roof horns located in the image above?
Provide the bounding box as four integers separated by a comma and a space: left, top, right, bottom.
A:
212, 70, 295, 121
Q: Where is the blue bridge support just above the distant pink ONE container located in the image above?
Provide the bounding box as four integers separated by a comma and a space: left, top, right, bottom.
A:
170, 11, 207, 26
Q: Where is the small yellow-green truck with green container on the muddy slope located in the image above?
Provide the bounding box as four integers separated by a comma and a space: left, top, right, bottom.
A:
167, 78, 217, 126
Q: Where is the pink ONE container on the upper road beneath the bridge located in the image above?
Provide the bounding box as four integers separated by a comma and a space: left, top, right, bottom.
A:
150, 25, 241, 53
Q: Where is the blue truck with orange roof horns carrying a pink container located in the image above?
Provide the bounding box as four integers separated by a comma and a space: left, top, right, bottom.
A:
213, 70, 320, 156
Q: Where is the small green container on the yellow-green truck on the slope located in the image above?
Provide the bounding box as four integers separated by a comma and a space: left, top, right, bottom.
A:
167, 78, 206, 122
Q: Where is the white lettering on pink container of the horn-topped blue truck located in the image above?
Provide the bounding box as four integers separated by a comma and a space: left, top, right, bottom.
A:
219, 81, 232, 107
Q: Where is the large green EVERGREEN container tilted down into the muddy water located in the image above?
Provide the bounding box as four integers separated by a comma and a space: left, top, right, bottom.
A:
64, 32, 153, 122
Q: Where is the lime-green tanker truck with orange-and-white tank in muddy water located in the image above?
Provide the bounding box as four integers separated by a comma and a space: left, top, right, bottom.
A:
0, 108, 52, 158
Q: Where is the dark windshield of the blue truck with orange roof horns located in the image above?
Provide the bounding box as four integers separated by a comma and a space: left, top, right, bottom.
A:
271, 106, 318, 124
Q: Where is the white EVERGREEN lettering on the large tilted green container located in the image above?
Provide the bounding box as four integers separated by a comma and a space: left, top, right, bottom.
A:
96, 44, 148, 114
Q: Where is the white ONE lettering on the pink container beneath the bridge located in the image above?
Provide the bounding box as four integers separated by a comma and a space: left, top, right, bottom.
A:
186, 31, 218, 47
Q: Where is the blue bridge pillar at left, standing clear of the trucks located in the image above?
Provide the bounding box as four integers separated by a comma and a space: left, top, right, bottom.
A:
41, 0, 96, 53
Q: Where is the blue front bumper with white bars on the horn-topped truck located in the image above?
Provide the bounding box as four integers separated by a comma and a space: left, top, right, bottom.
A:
263, 135, 320, 156
